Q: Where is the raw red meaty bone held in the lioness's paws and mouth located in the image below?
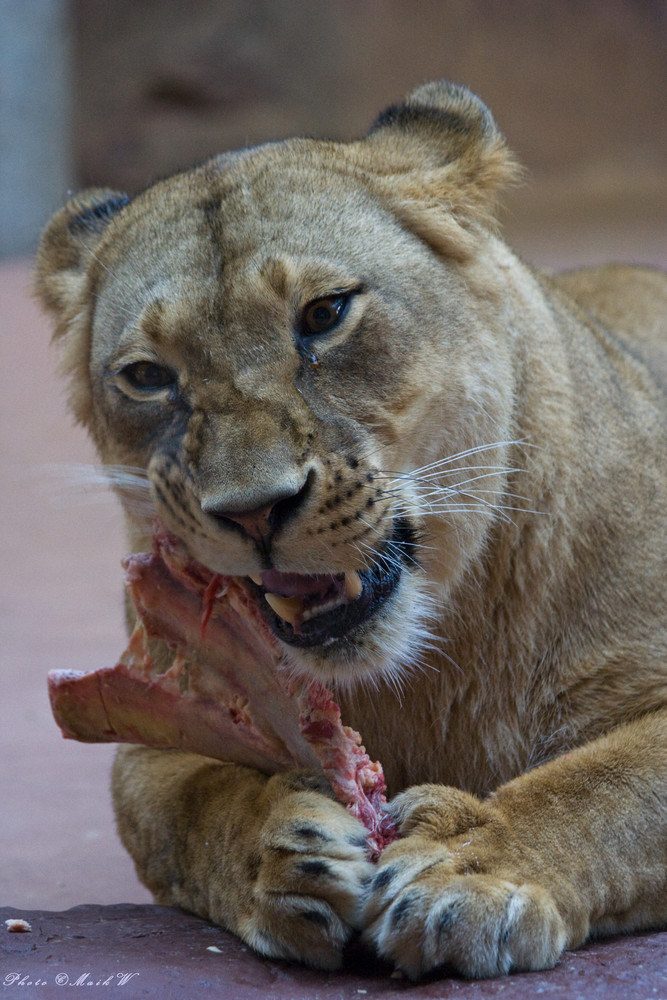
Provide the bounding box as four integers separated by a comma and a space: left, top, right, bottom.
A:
49, 526, 396, 857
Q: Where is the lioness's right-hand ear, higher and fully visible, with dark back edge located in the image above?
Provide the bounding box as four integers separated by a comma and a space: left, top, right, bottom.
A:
365, 81, 521, 253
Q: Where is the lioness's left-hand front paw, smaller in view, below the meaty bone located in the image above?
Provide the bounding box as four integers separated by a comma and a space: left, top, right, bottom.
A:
240, 777, 374, 969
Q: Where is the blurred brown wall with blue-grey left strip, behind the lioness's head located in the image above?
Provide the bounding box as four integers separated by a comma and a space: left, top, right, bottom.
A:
0, 0, 667, 262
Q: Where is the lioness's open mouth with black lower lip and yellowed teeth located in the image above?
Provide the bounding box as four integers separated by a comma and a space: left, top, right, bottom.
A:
252, 519, 415, 647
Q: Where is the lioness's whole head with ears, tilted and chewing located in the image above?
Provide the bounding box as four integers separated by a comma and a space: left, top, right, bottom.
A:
37, 83, 528, 681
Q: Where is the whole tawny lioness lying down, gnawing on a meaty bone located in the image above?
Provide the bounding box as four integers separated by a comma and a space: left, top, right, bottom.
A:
37, 83, 667, 978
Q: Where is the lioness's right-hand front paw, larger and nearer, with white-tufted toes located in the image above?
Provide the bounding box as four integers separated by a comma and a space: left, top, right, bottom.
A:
363, 789, 566, 979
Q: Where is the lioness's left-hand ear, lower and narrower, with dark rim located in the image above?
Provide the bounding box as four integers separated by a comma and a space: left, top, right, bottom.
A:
35, 188, 130, 322
